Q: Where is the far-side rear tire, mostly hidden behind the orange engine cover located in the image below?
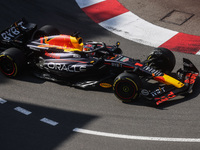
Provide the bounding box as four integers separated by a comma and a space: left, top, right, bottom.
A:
33, 25, 60, 39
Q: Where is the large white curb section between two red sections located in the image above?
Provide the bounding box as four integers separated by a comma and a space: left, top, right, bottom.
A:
99, 11, 178, 47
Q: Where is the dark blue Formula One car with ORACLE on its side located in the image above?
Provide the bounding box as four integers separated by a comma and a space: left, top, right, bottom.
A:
0, 19, 199, 105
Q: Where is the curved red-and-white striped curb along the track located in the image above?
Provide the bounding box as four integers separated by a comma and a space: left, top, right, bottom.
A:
76, 0, 200, 55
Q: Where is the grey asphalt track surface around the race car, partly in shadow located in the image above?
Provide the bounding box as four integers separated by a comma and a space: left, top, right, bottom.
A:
0, 0, 200, 150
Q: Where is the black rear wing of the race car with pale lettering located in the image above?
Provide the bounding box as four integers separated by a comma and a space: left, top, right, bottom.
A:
0, 18, 36, 42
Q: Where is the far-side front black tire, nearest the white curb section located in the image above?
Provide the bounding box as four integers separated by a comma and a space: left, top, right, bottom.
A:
147, 47, 176, 73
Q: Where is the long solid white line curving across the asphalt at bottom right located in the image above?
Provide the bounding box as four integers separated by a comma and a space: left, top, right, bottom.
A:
73, 128, 200, 143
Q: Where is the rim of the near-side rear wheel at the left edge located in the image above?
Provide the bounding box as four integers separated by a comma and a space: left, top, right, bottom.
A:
0, 56, 16, 76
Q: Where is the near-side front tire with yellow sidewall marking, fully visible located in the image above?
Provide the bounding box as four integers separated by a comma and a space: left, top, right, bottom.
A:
113, 72, 142, 103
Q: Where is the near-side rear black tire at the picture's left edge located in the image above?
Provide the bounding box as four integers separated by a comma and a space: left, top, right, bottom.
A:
0, 48, 25, 78
